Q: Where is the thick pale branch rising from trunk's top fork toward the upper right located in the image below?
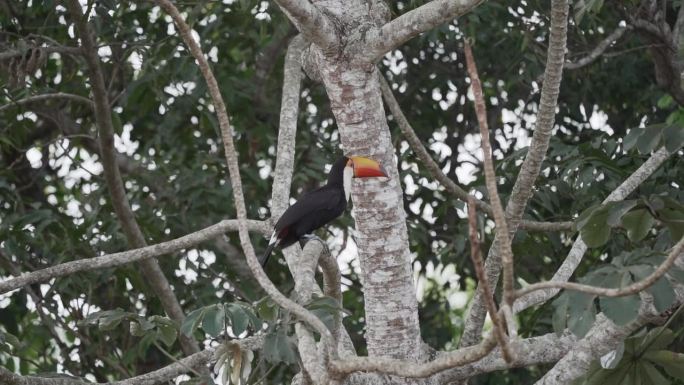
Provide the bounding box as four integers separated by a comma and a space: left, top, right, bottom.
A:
365, 0, 484, 63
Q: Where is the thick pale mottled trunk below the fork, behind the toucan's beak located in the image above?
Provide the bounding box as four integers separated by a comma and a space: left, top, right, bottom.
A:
319, 59, 421, 359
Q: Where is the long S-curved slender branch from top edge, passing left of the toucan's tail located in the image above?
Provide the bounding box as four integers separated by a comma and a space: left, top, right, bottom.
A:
155, 0, 334, 363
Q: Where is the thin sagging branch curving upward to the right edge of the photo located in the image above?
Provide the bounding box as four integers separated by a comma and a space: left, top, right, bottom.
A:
516, 237, 684, 297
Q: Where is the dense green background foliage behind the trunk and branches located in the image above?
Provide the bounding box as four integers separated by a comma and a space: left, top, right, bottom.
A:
0, 0, 684, 384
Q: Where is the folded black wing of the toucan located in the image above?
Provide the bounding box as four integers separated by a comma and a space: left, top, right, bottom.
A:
275, 186, 347, 237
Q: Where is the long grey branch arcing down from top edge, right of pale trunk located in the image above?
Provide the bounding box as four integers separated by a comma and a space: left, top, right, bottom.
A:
461, 0, 569, 346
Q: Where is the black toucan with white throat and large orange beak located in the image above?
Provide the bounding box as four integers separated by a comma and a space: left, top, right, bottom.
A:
261, 156, 387, 266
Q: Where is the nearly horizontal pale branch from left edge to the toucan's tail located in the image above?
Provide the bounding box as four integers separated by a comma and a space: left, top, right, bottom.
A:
0, 220, 270, 294
